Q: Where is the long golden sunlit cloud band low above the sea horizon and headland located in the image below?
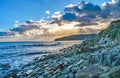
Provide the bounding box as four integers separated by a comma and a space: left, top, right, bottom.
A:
0, 20, 109, 41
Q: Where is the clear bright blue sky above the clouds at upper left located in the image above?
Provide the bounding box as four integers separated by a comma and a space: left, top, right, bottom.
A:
0, 0, 111, 31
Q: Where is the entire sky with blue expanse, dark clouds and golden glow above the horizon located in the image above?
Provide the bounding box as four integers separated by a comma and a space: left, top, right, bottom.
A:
0, 0, 120, 41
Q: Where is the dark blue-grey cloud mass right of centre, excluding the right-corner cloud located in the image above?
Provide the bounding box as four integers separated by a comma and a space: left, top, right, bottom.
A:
61, 1, 102, 21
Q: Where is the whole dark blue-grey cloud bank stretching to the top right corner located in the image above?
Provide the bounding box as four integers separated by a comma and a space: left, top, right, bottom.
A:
61, 0, 120, 22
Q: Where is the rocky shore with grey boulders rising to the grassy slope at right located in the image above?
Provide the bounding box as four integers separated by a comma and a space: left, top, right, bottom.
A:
5, 20, 120, 78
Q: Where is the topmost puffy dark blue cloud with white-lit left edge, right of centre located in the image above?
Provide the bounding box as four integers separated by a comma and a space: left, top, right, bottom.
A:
64, 1, 101, 14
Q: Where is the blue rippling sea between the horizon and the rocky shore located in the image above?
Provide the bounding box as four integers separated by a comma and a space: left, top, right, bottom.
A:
0, 41, 81, 77
